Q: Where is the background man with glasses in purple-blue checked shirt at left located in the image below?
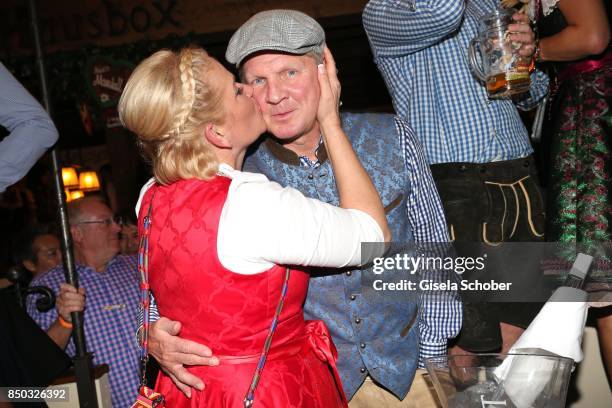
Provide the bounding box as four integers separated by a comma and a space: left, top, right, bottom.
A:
27, 198, 140, 407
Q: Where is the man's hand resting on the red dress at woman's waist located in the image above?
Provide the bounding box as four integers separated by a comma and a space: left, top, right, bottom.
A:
148, 317, 219, 398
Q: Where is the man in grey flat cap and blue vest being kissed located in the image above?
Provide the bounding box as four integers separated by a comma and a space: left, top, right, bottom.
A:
149, 10, 462, 407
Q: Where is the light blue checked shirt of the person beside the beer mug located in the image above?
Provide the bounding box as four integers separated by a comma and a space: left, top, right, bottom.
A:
363, 0, 548, 164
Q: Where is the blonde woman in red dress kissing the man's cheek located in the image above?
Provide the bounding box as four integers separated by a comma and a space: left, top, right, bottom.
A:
119, 48, 390, 407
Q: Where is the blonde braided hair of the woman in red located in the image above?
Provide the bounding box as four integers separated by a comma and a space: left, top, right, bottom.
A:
118, 47, 224, 184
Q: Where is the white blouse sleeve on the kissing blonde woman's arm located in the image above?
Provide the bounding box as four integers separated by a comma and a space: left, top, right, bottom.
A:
217, 171, 384, 274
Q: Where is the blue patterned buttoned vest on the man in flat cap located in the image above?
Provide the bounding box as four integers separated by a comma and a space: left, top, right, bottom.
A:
244, 114, 419, 398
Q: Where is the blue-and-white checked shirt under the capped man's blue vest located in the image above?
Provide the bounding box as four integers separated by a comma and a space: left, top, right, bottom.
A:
300, 122, 463, 367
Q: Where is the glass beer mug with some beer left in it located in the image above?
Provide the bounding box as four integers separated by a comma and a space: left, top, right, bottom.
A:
469, 8, 531, 98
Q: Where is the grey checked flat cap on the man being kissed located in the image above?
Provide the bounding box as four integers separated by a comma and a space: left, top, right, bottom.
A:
225, 10, 325, 67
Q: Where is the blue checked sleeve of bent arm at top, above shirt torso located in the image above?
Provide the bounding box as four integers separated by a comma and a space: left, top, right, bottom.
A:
363, 0, 465, 57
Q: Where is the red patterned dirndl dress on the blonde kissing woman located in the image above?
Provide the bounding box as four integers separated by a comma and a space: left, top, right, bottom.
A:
139, 176, 342, 407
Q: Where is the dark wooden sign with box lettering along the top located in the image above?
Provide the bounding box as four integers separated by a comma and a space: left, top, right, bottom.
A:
0, 0, 367, 55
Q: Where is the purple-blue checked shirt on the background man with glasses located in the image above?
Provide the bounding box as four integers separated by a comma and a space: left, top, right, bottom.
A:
27, 255, 140, 407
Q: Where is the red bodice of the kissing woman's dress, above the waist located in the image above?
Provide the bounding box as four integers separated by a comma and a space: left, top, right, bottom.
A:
143, 176, 308, 355
